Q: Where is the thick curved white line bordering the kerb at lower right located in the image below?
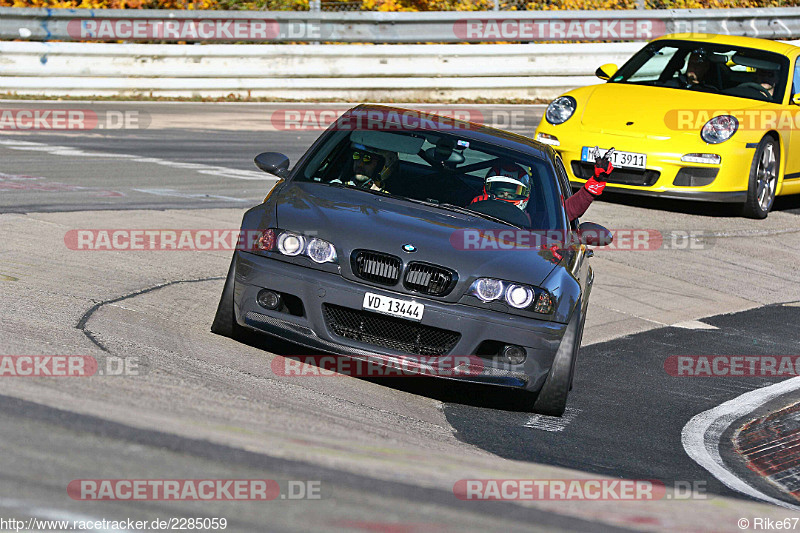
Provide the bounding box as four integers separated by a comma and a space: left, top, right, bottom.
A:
681, 376, 800, 511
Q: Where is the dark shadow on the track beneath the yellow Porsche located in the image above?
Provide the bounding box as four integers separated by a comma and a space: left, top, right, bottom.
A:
599, 192, 800, 218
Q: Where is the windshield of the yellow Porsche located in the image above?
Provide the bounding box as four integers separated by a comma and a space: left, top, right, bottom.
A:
609, 40, 789, 103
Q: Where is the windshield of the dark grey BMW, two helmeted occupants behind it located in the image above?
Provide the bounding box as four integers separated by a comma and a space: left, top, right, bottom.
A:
295, 130, 564, 230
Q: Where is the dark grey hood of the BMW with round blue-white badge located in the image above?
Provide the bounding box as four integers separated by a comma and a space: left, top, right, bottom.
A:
275, 183, 556, 299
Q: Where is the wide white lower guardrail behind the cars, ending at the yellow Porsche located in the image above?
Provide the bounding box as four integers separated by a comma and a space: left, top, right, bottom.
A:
0, 42, 642, 101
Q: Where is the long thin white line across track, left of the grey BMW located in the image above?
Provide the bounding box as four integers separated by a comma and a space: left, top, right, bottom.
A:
0, 139, 278, 181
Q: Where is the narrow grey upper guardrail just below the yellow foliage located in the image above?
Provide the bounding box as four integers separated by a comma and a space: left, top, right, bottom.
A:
0, 8, 800, 43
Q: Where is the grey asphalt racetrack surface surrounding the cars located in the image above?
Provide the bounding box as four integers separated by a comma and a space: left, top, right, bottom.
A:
0, 103, 800, 531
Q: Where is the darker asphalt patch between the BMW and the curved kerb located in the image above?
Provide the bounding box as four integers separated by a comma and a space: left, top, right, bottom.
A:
445, 305, 800, 502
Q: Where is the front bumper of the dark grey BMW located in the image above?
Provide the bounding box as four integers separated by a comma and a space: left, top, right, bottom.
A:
234, 252, 571, 392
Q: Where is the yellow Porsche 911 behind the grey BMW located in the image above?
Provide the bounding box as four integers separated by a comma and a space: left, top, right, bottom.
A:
535, 34, 800, 218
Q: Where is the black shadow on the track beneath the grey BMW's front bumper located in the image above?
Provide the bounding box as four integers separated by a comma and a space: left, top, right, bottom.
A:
231, 330, 536, 412
